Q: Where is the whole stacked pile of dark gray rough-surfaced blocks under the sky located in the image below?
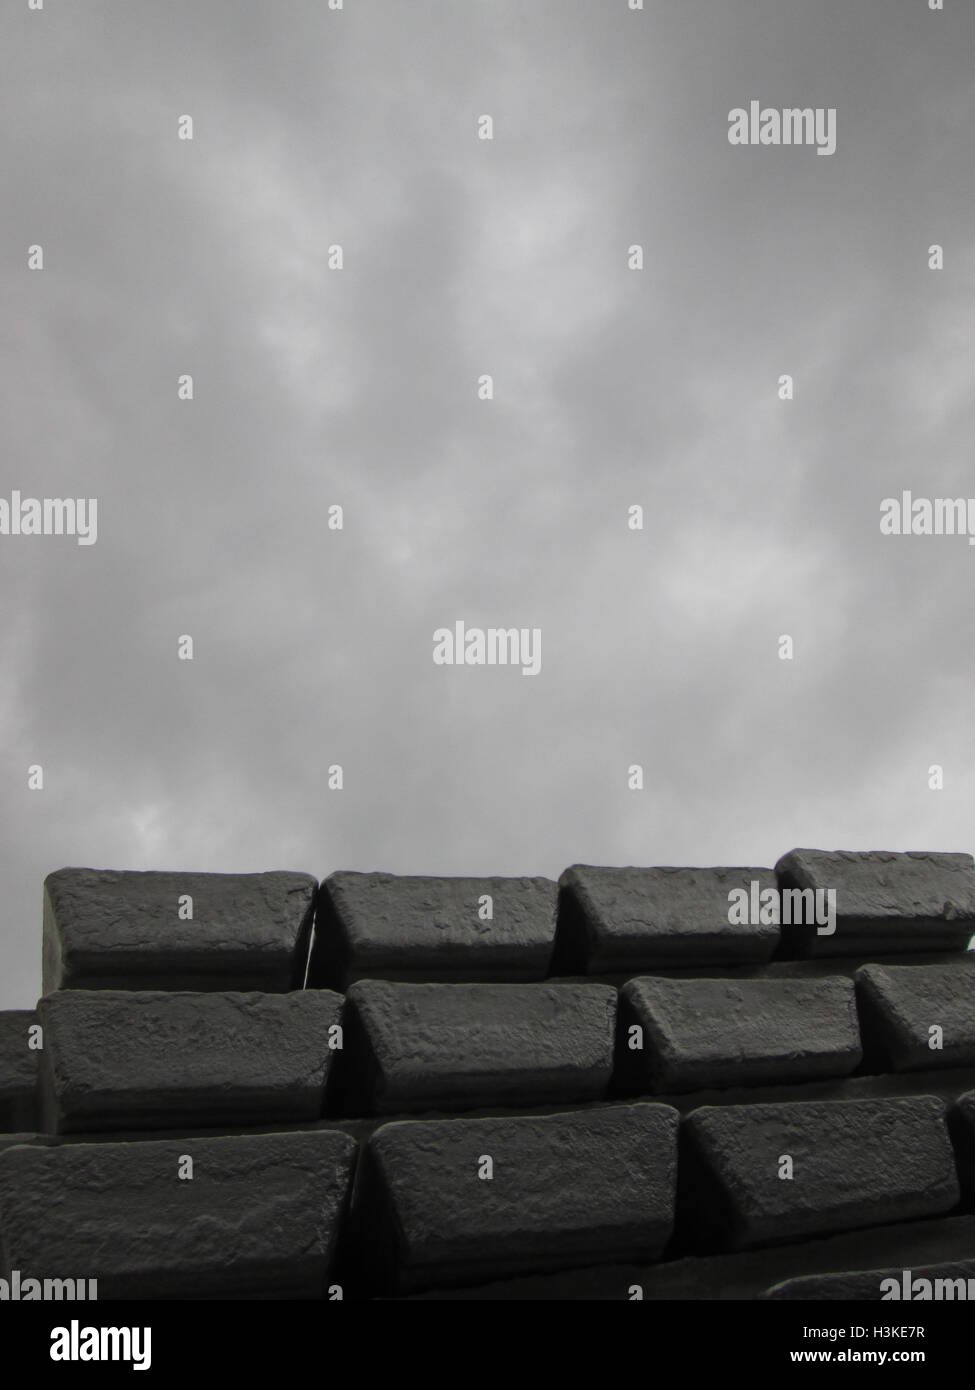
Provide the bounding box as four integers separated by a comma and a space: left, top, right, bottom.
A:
0, 851, 975, 1301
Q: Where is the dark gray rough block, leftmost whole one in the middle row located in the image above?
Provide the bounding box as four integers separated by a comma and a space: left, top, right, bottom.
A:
38, 990, 344, 1134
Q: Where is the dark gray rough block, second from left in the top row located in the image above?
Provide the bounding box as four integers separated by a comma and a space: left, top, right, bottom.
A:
310, 872, 558, 988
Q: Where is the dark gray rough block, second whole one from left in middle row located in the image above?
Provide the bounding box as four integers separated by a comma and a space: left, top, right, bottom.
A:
341, 980, 616, 1115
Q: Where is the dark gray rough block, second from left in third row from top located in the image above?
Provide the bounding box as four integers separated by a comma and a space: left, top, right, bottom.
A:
357, 1104, 677, 1291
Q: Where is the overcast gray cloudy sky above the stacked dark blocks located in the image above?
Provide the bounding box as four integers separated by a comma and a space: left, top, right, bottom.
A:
0, 0, 975, 1008
